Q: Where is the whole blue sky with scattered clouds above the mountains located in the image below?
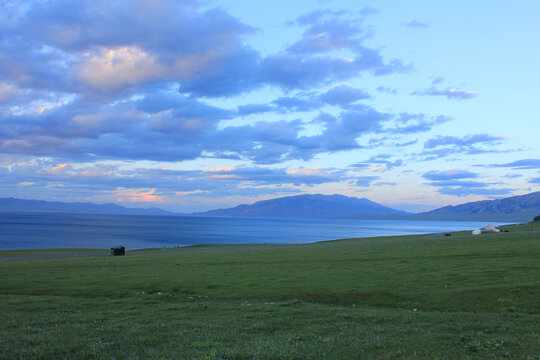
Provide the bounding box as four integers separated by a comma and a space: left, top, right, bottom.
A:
0, 0, 540, 212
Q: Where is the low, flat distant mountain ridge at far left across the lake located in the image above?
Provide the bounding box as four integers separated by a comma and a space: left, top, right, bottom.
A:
0, 198, 174, 215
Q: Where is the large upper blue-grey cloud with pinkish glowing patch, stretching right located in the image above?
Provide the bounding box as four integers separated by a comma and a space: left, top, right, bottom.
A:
0, 0, 403, 99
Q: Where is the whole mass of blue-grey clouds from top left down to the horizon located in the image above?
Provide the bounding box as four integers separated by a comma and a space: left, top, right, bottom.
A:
0, 0, 466, 211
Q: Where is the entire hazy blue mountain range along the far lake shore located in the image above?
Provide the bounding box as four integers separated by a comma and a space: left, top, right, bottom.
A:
0, 191, 540, 222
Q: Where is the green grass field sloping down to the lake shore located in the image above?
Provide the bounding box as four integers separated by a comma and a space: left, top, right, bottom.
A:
0, 224, 540, 360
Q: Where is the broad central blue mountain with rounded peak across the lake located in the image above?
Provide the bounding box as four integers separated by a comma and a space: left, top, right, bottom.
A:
194, 195, 407, 218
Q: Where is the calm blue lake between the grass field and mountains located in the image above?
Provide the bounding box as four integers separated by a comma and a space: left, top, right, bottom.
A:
0, 212, 508, 250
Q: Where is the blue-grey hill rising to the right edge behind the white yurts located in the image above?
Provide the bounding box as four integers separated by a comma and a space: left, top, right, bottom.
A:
416, 191, 540, 222
